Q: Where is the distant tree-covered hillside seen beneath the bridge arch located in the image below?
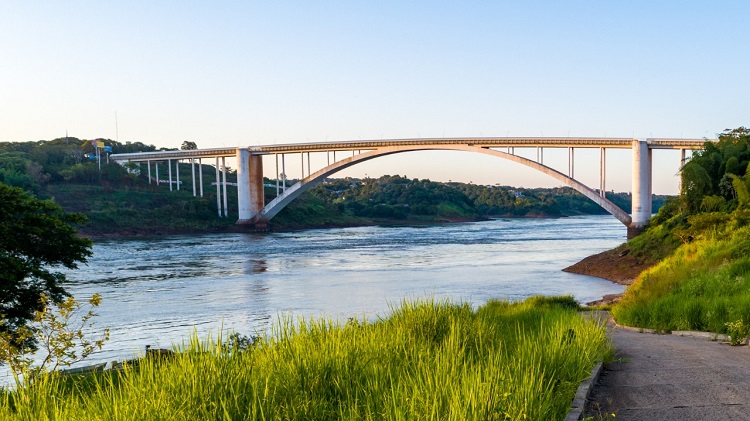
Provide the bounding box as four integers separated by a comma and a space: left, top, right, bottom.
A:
274, 175, 666, 227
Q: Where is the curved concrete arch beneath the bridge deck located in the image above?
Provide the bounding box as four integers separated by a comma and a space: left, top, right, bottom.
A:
252, 145, 632, 227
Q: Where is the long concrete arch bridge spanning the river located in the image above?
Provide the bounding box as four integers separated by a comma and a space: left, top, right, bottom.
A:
110, 137, 707, 237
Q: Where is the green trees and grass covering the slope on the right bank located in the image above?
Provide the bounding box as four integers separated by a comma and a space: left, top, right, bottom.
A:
612, 127, 750, 338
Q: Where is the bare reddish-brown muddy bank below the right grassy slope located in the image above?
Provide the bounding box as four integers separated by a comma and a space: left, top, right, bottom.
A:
563, 244, 652, 305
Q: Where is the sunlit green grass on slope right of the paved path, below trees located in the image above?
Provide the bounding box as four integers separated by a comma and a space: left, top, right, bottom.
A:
612, 221, 750, 333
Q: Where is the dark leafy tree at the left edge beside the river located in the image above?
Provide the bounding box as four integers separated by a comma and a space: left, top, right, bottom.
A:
0, 183, 92, 352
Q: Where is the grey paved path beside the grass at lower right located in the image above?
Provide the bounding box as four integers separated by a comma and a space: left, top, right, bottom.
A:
585, 320, 750, 421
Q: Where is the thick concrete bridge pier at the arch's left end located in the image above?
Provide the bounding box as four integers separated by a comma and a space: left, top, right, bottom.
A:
237, 148, 265, 225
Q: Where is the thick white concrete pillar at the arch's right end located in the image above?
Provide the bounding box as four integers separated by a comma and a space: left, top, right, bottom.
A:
628, 140, 651, 238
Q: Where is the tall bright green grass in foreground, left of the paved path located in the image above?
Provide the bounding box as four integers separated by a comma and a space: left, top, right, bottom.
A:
0, 297, 610, 420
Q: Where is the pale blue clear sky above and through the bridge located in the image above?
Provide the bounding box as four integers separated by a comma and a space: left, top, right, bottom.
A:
0, 0, 750, 194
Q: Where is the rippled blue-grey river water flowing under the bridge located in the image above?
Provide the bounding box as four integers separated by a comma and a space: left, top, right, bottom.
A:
0, 216, 626, 377
